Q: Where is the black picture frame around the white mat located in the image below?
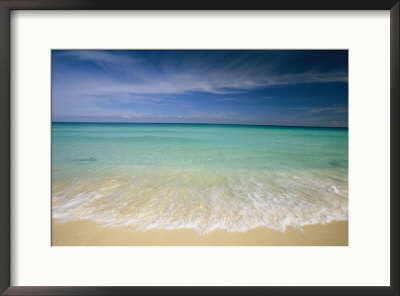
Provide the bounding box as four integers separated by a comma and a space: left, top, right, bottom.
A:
0, 0, 400, 295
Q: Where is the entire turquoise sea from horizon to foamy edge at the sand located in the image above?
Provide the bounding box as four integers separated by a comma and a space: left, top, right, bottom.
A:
52, 123, 348, 233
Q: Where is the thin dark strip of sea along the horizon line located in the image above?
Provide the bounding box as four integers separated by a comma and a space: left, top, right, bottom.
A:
51, 121, 349, 129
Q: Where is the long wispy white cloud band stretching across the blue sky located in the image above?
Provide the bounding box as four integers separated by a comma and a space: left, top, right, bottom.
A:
54, 68, 347, 95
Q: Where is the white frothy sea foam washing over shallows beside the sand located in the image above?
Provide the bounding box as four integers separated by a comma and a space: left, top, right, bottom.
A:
53, 168, 348, 233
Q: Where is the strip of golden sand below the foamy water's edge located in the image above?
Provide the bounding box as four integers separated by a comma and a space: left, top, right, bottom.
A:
52, 219, 348, 246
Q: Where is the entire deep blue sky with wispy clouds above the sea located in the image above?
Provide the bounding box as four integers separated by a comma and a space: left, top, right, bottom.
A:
52, 50, 348, 127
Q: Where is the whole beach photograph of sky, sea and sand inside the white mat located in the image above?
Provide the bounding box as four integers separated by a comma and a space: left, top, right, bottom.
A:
49, 49, 349, 246
